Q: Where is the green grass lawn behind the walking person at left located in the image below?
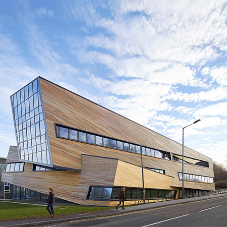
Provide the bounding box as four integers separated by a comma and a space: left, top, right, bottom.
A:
0, 202, 112, 221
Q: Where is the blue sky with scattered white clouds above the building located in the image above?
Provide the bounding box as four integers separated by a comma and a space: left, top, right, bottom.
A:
0, 0, 227, 167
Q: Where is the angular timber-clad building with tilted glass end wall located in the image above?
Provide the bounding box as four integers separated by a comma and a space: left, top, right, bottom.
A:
2, 77, 215, 206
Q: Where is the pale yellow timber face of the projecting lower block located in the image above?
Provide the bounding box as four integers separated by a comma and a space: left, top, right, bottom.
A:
114, 161, 174, 190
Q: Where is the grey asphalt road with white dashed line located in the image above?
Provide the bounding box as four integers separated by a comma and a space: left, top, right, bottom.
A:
48, 197, 227, 227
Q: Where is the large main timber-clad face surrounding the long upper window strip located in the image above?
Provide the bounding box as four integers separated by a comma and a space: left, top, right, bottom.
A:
40, 78, 213, 192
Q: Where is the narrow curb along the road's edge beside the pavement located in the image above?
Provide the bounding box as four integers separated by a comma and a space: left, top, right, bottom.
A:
0, 194, 227, 227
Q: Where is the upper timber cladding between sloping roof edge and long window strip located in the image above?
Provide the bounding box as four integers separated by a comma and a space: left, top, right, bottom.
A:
40, 78, 211, 162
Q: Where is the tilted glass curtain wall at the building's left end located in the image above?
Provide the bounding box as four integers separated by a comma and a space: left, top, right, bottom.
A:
11, 78, 52, 166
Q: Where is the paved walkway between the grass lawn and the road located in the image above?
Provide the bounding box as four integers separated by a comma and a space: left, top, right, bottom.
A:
0, 194, 227, 227
